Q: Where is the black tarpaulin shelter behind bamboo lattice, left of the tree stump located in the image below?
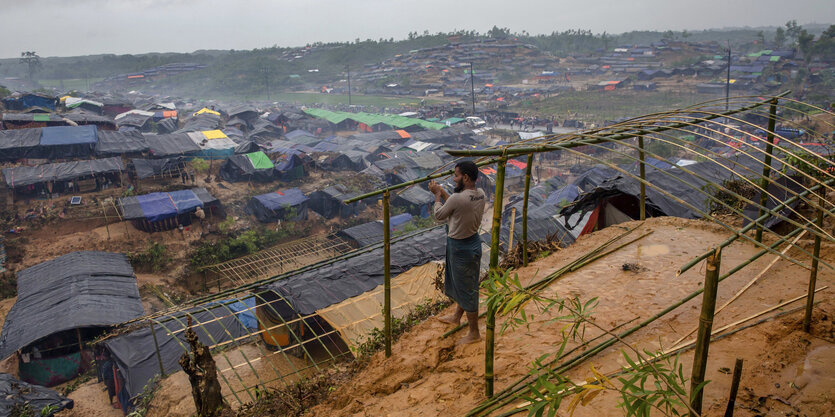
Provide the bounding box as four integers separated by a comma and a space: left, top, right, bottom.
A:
102, 303, 248, 398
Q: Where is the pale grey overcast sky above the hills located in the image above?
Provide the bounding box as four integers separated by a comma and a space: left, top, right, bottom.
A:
0, 0, 835, 58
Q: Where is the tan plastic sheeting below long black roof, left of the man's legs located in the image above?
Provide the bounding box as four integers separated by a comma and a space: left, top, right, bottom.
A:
317, 262, 445, 350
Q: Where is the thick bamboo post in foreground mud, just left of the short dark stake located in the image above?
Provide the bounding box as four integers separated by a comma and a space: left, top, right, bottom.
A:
690, 248, 722, 417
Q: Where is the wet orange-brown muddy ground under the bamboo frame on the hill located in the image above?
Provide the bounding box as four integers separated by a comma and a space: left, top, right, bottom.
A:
310, 218, 835, 416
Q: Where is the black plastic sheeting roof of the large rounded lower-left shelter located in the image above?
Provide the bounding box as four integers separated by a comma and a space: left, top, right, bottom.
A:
0, 252, 144, 358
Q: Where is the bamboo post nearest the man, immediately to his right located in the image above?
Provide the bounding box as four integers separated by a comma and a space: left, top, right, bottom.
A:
484, 154, 507, 398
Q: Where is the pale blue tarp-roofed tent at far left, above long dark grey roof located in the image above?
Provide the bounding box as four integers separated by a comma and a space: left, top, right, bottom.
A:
37, 125, 98, 159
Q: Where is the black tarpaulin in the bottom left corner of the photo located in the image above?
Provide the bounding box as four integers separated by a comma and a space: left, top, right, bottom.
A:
0, 373, 75, 417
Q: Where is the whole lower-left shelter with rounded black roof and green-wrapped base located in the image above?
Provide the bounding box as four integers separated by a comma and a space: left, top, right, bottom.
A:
0, 252, 144, 386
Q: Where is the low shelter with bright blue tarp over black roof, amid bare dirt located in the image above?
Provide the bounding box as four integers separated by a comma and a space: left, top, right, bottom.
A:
119, 187, 220, 232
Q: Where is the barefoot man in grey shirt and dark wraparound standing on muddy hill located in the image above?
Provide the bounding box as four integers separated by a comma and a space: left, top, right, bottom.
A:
429, 161, 486, 344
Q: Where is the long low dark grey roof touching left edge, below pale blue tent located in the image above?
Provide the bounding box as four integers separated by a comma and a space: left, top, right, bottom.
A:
3, 157, 124, 188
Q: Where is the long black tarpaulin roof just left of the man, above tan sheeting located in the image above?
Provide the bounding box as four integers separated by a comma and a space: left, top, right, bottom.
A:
259, 226, 446, 315
